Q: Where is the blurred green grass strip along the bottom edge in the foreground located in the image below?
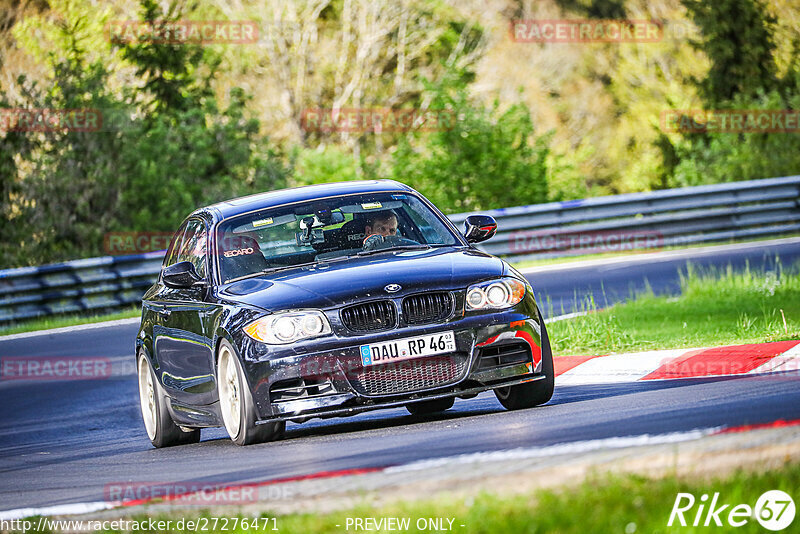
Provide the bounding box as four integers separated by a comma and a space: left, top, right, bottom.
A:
34, 460, 800, 534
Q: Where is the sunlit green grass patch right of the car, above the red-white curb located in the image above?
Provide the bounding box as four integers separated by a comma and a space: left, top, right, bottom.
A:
548, 264, 800, 356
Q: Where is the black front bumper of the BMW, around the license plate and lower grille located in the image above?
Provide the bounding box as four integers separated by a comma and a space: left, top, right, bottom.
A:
243, 298, 551, 423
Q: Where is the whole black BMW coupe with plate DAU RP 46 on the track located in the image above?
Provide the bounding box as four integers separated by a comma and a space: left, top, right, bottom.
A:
136, 181, 553, 447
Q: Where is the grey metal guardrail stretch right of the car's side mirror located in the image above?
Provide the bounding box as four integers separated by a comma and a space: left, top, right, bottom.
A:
450, 176, 800, 261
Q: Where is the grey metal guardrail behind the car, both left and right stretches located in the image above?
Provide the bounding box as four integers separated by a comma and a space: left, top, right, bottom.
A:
0, 176, 800, 324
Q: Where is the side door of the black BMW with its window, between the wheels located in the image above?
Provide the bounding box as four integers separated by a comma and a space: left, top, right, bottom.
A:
152, 218, 216, 405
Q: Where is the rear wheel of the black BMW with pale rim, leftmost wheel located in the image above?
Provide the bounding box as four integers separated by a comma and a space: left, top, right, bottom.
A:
137, 353, 200, 449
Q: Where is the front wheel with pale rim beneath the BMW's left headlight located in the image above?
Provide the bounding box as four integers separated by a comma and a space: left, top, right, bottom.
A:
217, 340, 286, 445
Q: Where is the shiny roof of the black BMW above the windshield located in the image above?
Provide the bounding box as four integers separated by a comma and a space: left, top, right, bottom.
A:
200, 180, 414, 219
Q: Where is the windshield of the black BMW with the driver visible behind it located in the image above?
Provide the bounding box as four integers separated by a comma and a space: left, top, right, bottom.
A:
217, 193, 461, 283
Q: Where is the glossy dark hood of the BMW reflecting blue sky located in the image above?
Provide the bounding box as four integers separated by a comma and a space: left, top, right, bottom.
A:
219, 247, 506, 311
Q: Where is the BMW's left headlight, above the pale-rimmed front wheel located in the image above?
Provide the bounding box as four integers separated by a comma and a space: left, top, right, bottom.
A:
244, 310, 331, 345
